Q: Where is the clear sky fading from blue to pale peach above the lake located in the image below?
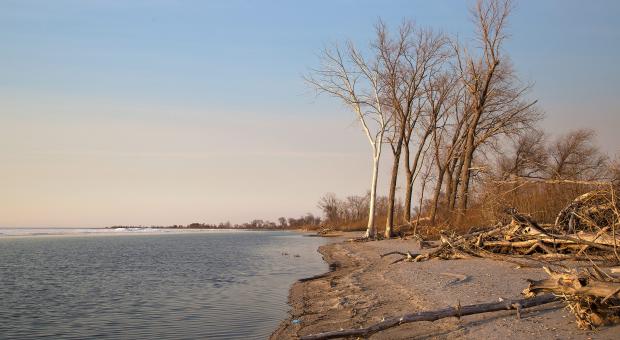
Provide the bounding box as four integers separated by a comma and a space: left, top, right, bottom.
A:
0, 0, 620, 227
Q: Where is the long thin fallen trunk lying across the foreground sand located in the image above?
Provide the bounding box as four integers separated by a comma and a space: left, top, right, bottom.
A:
300, 294, 559, 340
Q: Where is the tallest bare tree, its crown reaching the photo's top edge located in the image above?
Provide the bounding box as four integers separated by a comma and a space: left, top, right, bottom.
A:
455, 0, 534, 220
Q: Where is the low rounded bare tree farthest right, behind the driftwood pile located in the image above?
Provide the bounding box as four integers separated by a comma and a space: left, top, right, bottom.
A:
547, 129, 608, 180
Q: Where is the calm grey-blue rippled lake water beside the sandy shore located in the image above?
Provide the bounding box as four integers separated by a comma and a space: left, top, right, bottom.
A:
0, 231, 327, 339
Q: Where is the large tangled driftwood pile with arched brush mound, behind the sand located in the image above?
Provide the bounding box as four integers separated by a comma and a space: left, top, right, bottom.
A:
382, 190, 620, 265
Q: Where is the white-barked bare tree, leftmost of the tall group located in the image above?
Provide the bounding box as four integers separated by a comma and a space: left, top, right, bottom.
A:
305, 42, 390, 238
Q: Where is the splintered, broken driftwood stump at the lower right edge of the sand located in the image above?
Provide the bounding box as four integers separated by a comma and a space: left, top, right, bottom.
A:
523, 266, 620, 329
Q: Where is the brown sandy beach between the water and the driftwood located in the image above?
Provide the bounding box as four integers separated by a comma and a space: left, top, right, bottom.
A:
271, 239, 620, 339
